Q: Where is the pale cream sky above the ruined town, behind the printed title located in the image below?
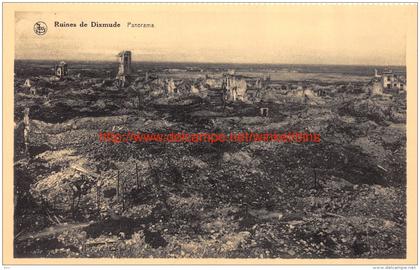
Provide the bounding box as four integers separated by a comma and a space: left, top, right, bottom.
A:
15, 4, 416, 65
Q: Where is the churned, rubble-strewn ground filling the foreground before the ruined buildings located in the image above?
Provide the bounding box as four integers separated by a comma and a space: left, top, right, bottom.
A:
14, 61, 406, 258
